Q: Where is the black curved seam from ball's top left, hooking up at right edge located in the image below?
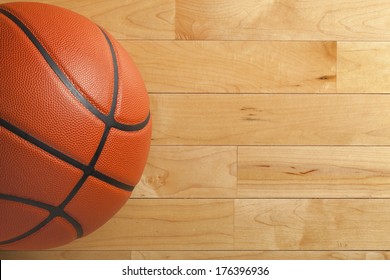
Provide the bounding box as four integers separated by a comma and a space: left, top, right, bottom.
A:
0, 8, 150, 131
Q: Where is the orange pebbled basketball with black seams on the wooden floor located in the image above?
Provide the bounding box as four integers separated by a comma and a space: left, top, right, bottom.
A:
0, 3, 151, 250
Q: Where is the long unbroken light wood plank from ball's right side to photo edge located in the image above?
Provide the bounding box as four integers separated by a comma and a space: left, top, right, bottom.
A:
151, 94, 390, 145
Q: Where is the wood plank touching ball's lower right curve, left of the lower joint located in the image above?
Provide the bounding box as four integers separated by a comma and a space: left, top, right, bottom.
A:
57, 199, 234, 250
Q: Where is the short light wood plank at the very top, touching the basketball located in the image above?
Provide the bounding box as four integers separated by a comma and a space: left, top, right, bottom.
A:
0, 0, 175, 39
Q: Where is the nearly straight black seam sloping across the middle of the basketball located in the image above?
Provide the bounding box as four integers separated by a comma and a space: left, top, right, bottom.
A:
0, 118, 134, 190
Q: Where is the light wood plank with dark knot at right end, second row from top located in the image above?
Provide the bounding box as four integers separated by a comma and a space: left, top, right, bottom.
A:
122, 41, 336, 93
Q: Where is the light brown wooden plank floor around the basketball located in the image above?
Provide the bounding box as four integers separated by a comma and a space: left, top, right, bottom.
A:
0, 0, 390, 259
